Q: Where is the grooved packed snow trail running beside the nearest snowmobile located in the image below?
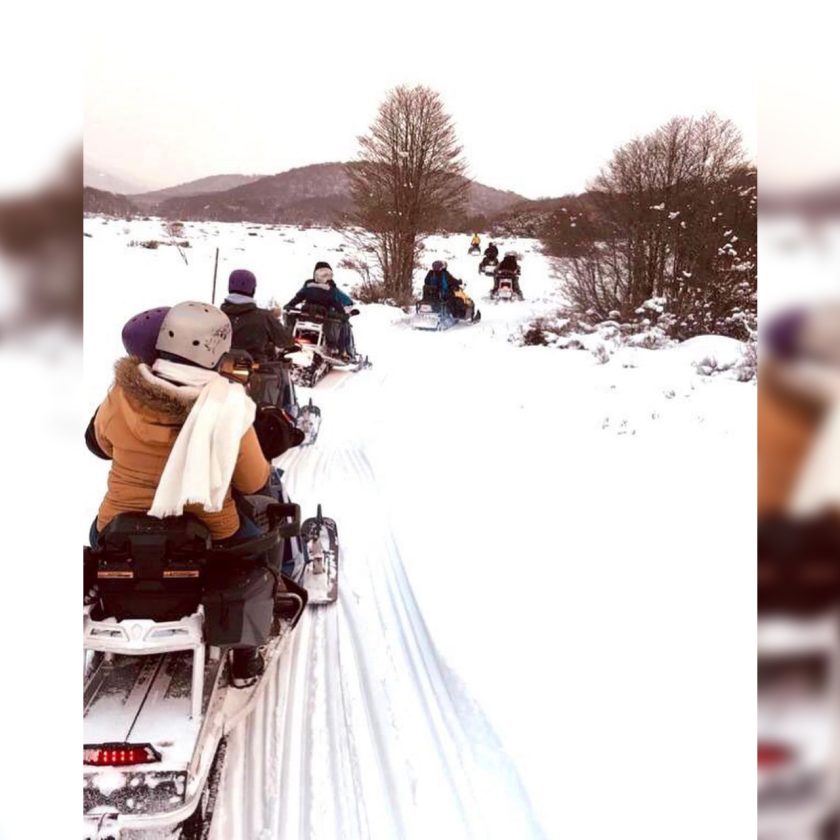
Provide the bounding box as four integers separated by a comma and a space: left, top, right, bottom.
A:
212, 377, 542, 840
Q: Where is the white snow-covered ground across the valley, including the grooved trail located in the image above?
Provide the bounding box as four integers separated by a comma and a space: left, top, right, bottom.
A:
80, 218, 755, 840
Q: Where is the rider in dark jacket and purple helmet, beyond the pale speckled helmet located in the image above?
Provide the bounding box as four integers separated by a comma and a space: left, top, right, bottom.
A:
221, 268, 296, 362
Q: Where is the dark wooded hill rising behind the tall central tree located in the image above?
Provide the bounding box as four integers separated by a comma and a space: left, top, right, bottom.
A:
156, 163, 525, 224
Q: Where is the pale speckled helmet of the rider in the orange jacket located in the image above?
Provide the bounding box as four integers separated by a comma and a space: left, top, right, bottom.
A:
155, 300, 232, 370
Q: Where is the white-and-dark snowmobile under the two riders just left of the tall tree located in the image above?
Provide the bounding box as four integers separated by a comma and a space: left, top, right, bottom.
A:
286, 304, 371, 388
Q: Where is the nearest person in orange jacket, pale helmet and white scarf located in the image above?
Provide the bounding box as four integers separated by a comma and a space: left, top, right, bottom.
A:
90, 301, 278, 685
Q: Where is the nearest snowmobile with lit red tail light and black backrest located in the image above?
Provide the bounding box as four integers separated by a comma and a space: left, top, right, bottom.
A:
83, 496, 308, 840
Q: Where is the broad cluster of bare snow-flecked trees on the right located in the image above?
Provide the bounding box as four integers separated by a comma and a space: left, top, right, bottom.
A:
546, 114, 756, 337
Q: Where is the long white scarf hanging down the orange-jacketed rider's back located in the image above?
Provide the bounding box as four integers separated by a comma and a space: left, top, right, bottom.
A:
144, 359, 256, 519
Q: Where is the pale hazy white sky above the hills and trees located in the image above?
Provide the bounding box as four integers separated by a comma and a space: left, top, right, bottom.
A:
85, 0, 757, 197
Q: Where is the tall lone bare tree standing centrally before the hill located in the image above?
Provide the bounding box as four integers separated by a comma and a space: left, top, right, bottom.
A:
346, 86, 469, 302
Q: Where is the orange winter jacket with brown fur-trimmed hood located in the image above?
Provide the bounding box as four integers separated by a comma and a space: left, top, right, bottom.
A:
94, 357, 271, 540
